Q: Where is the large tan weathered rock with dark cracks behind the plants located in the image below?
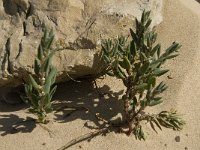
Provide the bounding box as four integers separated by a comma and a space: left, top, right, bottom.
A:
0, 0, 162, 87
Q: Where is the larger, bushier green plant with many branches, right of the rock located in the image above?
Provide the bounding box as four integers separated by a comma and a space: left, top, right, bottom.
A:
102, 11, 185, 140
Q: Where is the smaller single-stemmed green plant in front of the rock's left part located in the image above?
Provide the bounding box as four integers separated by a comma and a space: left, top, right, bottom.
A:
22, 28, 57, 123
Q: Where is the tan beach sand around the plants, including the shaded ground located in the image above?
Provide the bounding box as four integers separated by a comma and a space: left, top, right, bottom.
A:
0, 0, 200, 150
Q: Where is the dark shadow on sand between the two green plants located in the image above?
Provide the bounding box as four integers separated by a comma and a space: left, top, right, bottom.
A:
54, 80, 123, 129
